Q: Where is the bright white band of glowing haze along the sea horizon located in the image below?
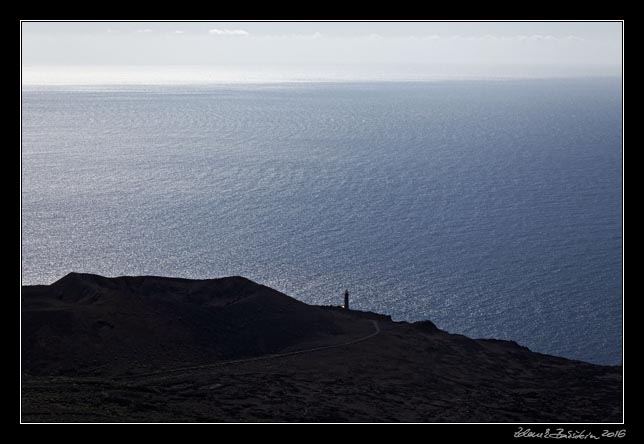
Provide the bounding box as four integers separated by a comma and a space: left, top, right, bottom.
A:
22, 63, 620, 89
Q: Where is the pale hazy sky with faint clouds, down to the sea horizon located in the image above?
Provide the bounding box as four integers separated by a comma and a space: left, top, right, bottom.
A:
22, 22, 622, 83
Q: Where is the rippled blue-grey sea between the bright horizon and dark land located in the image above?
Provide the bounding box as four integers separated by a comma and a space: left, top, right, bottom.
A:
21, 78, 622, 364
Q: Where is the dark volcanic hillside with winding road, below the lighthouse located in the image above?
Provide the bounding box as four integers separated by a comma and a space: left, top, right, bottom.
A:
22, 273, 622, 422
